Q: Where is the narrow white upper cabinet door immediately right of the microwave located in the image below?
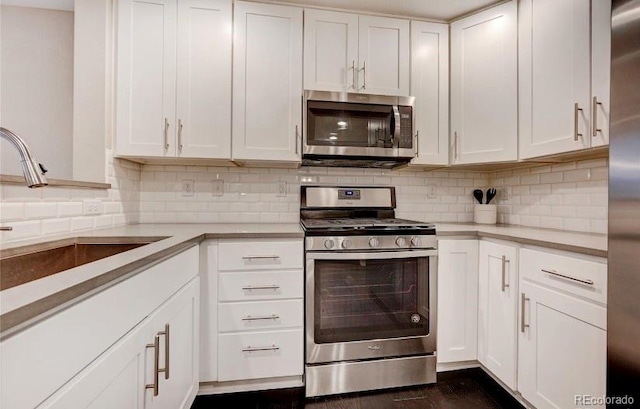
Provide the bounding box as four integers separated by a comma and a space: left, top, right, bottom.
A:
411, 21, 449, 165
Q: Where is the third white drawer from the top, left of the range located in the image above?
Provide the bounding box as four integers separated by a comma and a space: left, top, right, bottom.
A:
218, 300, 303, 332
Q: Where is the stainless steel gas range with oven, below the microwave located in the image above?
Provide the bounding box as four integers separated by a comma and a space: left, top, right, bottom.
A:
300, 186, 437, 397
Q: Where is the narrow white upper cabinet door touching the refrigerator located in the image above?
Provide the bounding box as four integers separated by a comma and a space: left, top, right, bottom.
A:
591, 0, 611, 146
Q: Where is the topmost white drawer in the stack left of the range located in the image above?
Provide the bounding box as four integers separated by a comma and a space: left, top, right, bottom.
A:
218, 239, 304, 271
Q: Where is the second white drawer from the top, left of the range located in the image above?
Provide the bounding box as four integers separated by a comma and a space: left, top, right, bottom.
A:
218, 270, 304, 301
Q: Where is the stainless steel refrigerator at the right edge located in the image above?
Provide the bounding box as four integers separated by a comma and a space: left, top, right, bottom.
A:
607, 0, 640, 398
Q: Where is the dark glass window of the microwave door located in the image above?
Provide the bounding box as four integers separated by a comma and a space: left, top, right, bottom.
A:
307, 101, 394, 148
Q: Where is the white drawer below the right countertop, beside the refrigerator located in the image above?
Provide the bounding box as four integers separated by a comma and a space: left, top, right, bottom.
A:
520, 249, 607, 304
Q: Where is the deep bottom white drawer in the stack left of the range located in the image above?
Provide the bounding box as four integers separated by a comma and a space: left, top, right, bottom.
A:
218, 329, 303, 381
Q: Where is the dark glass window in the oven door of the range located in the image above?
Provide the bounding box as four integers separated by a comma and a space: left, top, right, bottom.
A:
314, 257, 429, 344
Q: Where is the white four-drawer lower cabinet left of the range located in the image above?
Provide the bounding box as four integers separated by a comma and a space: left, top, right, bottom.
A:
200, 239, 304, 393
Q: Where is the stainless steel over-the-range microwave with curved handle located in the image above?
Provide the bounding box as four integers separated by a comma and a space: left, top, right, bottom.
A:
302, 91, 415, 168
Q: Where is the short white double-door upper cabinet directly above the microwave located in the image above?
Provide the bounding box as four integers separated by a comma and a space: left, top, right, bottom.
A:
304, 9, 409, 96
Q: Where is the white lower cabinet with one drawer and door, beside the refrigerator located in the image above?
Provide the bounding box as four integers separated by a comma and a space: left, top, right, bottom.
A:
518, 249, 607, 409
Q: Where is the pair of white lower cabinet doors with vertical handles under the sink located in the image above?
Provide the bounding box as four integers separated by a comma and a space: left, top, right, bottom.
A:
38, 249, 200, 409
